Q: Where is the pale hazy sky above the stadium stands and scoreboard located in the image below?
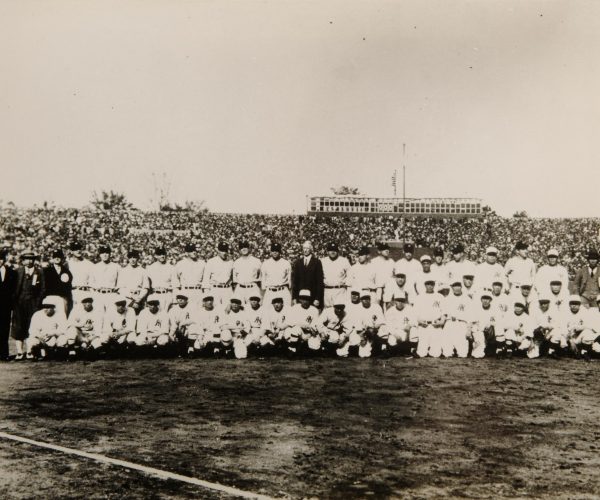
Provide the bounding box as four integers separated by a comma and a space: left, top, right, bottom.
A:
0, 0, 600, 217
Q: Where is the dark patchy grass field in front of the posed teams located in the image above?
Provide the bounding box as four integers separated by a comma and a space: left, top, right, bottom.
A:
0, 358, 600, 499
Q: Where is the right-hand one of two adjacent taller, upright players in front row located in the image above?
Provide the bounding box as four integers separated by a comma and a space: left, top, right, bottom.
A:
442, 280, 473, 358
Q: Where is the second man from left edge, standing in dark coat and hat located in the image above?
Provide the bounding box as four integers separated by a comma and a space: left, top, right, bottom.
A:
11, 250, 45, 359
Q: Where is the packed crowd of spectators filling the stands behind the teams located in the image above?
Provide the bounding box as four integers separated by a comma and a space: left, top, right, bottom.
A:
0, 208, 600, 276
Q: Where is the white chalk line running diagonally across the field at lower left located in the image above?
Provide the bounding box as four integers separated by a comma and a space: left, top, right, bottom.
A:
0, 432, 274, 500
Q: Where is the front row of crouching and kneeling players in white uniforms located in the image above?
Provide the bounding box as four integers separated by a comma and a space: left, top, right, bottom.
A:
17, 282, 600, 359
